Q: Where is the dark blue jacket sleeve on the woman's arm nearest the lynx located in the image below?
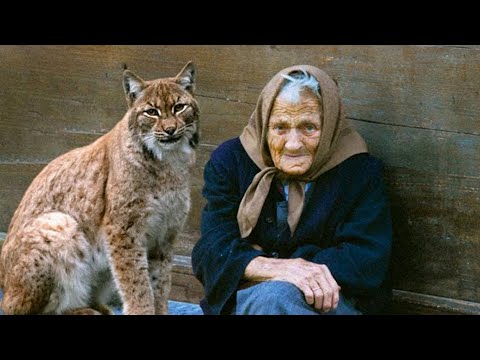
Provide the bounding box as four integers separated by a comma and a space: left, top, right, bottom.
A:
192, 149, 264, 314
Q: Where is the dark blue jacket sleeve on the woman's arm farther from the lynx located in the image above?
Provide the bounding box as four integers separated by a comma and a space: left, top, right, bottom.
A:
291, 162, 392, 292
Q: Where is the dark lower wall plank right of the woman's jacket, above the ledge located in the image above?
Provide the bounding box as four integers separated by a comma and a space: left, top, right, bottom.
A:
386, 168, 480, 302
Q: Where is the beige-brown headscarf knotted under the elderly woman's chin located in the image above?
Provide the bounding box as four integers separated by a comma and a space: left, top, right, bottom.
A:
237, 65, 368, 238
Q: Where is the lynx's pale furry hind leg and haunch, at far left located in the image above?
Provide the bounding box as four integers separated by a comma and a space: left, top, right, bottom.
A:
2, 212, 92, 314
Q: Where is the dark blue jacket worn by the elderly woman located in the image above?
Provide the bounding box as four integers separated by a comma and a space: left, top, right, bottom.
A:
192, 138, 392, 314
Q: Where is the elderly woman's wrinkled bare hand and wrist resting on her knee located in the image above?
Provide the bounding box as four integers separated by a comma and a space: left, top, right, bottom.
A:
244, 256, 340, 312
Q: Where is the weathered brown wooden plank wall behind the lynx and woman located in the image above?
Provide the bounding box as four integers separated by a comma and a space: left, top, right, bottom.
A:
0, 45, 480, 302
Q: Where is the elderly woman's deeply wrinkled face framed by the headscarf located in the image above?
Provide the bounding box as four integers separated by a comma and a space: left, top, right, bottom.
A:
267, 89, 322, 176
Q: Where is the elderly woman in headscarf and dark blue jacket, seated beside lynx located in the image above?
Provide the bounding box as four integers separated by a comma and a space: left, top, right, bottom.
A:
192, 65, 392, 315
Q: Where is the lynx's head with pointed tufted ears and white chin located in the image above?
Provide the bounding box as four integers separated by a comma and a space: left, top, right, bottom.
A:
124, 63, 199, 160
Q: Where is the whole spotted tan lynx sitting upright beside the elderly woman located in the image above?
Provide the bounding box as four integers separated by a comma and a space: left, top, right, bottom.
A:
0, 62, 199, 314
